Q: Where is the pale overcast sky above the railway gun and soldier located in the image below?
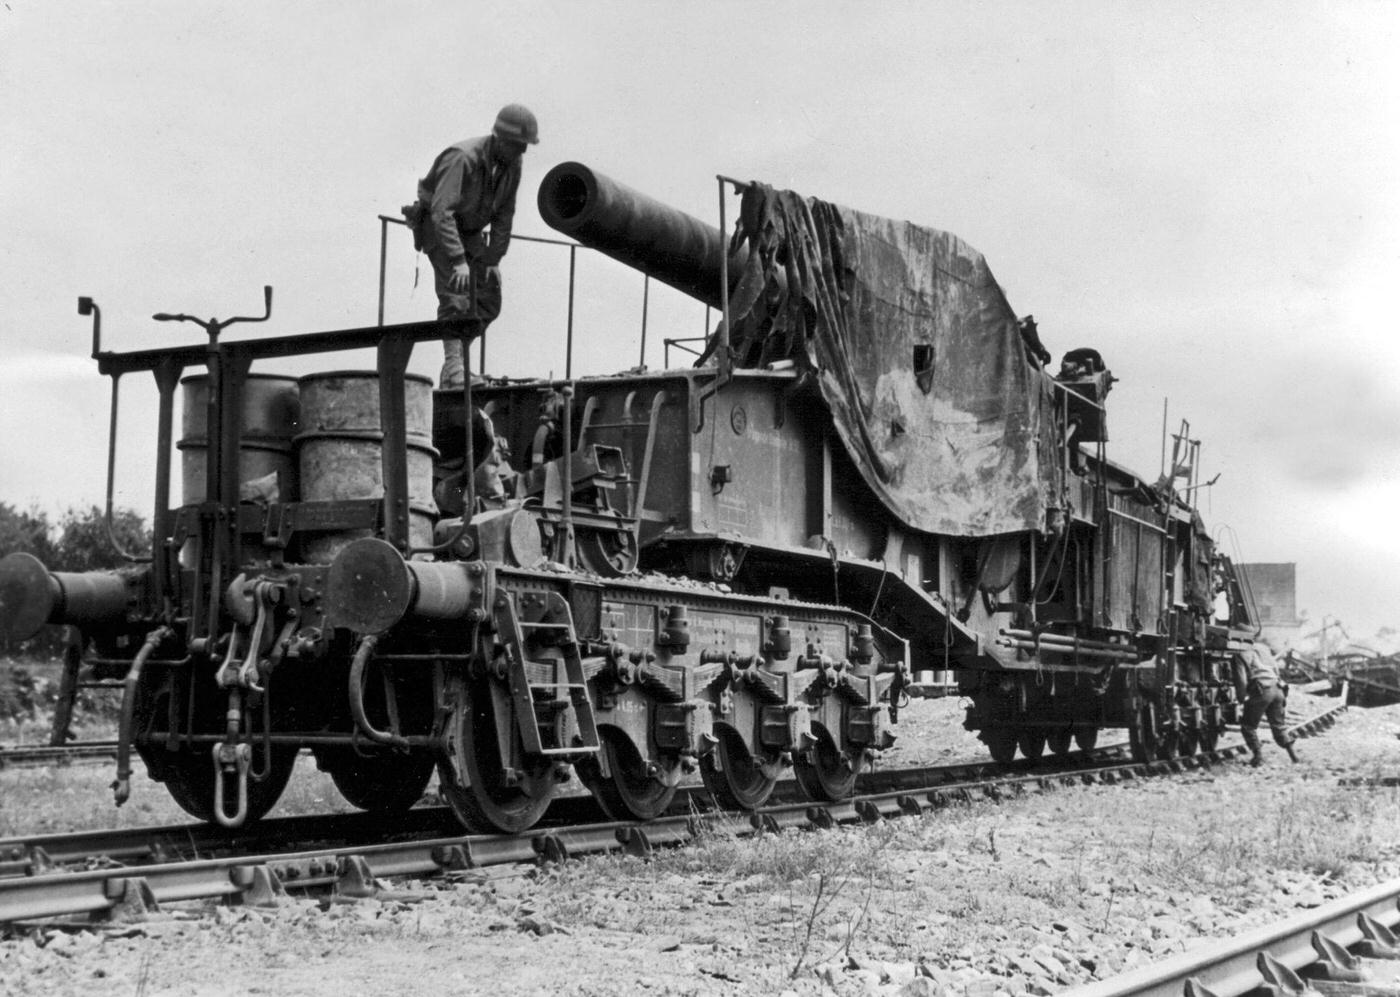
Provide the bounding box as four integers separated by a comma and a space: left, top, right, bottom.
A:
0, 0, 1400, 636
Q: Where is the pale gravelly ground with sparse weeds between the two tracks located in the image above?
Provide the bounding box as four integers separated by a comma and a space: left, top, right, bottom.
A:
0, 696, 1400, 997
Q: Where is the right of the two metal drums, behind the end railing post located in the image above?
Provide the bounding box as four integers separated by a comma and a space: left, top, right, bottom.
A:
295, 371, 437, 564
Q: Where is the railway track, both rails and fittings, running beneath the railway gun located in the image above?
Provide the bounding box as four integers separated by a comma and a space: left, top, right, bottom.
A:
0, 706, 1345, 923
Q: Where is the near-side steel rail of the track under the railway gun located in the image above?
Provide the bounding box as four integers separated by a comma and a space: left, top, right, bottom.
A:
0, 706, 1345, 923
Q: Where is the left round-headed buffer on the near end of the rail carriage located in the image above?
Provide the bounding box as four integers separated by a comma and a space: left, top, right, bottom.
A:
0, 552, 136, 640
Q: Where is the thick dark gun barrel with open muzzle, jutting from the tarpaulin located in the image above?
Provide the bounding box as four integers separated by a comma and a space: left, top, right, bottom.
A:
539, 162, 748, 308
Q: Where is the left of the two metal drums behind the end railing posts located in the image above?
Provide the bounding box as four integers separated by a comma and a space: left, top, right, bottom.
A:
176, 374, 301, 506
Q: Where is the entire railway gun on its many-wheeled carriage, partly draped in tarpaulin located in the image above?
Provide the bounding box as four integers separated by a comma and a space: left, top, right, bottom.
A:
0, 162, 1257, 833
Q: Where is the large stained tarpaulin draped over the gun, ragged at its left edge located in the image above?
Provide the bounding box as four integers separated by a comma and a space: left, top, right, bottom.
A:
731, 183, 1058, 536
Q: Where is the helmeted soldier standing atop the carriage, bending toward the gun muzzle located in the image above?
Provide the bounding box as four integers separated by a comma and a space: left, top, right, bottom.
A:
403, 104, 539, 388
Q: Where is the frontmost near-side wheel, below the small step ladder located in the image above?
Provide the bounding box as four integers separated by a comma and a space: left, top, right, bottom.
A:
438, 681, 554, 835
